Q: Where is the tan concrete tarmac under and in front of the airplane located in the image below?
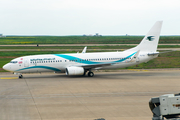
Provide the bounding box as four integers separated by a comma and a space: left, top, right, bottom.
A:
0, 69, 180, 120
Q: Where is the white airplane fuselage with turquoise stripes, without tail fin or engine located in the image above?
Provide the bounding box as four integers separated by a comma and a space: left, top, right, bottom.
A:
4, 52, 157, 73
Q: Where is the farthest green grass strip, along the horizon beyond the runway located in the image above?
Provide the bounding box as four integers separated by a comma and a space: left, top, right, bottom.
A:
0, 36, 180, 45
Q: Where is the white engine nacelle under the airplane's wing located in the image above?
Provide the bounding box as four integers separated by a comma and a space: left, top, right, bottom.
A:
66, 67, 84, 75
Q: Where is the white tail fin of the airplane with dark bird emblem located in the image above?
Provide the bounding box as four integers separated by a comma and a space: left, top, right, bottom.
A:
127, 21, 162, 52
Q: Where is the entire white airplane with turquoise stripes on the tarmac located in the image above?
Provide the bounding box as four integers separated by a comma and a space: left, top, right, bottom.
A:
3, 21, 162, 78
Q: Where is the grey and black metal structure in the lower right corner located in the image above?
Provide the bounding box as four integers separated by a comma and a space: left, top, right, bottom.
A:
149, 93, 180, 120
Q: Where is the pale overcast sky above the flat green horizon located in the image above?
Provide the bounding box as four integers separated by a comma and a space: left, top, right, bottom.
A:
0, 0, 180, 35
